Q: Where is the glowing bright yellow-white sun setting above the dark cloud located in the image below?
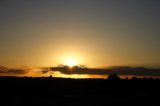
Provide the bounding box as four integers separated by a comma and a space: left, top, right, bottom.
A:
64, 57, 78, 67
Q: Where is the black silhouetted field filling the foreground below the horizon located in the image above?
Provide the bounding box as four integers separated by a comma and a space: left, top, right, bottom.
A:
0, 77, 160, 106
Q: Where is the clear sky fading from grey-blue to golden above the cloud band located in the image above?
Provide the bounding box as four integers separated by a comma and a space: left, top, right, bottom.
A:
0, 0, 160, 67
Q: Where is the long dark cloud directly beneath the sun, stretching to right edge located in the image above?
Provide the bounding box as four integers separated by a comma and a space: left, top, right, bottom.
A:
50, 66, 160, 76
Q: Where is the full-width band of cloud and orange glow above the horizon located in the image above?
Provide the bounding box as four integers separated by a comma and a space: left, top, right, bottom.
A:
0, 66, 160, 77
